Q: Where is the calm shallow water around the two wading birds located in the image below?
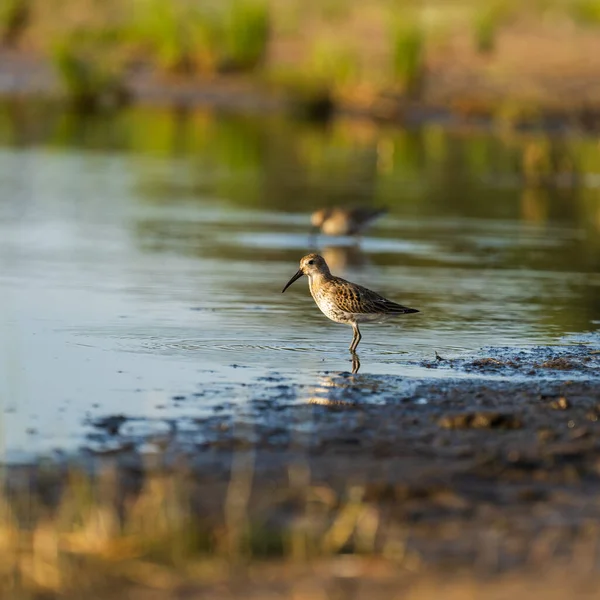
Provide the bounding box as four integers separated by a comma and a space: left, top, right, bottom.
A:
0, 105, 600, 460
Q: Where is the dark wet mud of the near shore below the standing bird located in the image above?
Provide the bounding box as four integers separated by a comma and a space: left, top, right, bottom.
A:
7, 345, 600, 572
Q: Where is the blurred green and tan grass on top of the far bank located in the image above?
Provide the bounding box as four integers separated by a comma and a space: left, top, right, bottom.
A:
0, 0, 600, 114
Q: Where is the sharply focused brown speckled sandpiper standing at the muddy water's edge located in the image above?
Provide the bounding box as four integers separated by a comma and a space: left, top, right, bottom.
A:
281, 254, 419, 354
